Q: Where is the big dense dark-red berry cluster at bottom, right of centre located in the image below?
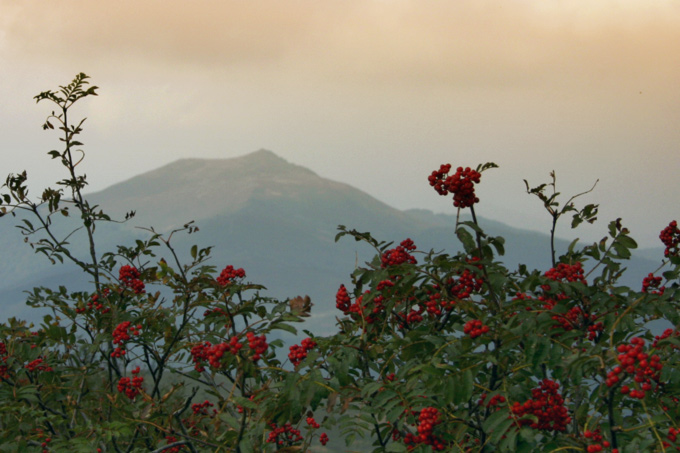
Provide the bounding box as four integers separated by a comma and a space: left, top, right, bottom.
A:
510, 379, 571, 431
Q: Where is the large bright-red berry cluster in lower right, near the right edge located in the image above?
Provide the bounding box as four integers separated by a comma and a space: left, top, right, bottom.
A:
605, 337, 663, 399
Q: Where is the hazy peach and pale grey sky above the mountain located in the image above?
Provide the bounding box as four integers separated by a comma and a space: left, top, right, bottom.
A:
0, 0, 680, 245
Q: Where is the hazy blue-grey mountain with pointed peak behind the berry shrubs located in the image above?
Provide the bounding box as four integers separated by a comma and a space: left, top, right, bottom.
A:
0, 150, 662, 333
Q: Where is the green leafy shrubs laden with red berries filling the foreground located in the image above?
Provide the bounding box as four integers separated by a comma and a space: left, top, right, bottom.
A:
0, 74, 680, 453
